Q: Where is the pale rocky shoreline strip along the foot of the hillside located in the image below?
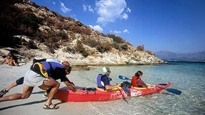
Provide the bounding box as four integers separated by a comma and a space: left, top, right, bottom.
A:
0, 48, 167, 70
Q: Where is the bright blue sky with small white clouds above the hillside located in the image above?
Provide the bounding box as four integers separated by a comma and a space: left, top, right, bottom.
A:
31, 0, 205, 53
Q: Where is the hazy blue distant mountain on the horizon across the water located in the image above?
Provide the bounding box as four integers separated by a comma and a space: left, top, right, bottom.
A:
155, 51, 205, 62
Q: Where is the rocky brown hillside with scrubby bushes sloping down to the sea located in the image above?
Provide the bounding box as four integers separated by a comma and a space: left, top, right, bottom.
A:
0, 0, 164, 65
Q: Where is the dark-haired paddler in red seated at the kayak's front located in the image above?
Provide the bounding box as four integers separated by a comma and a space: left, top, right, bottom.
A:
131, 71, 148, 88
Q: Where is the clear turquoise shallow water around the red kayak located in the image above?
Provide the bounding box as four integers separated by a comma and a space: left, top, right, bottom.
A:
71, 62, 205, 115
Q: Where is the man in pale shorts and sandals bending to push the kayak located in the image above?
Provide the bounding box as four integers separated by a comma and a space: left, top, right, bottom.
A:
0, 61, 76, 109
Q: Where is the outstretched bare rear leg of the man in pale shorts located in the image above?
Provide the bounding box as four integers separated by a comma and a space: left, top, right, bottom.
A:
0, 85, 33, 102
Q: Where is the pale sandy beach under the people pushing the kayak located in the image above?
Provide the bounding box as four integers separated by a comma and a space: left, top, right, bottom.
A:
0, 63, 105, 115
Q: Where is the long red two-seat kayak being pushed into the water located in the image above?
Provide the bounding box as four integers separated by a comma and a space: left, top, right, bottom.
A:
55, 82, 171, 102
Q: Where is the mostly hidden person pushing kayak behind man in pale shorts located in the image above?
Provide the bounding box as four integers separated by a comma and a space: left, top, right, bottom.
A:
0, 58, 74, 97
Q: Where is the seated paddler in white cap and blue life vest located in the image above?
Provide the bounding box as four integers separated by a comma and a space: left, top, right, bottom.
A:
97, 67, 120, 90
